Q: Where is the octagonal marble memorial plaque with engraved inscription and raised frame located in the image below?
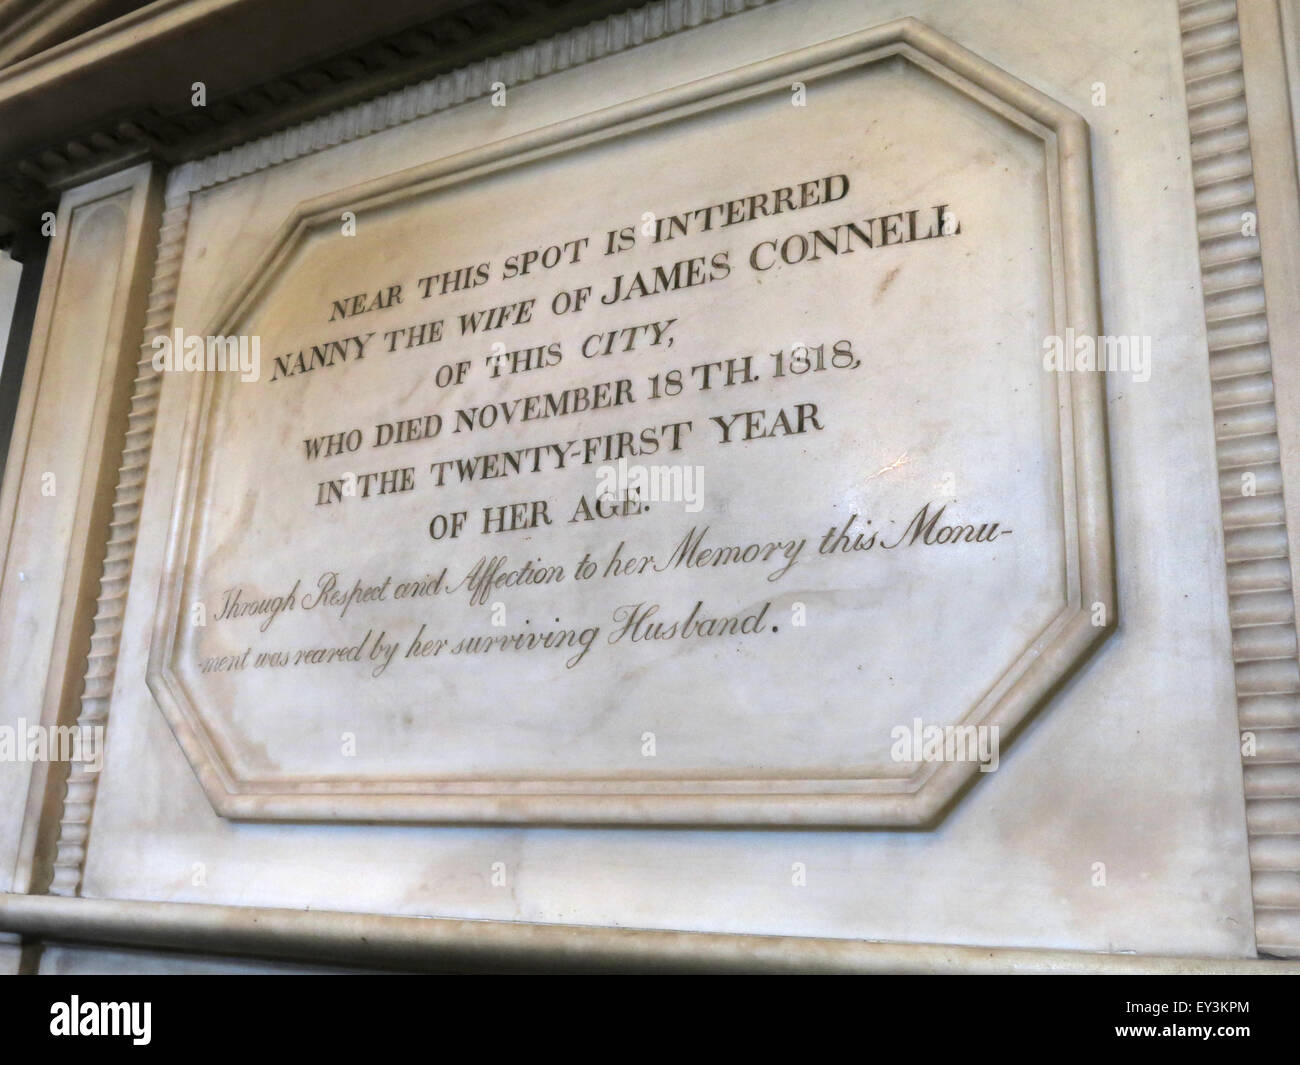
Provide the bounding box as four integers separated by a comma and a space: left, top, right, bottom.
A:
150, 23, 1114, 826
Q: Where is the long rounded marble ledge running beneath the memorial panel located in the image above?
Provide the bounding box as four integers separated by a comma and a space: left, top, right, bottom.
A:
0, 893, 1300, 975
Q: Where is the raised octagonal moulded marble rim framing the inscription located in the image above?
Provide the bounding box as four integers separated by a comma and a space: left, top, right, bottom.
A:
147, 18, 1117, 827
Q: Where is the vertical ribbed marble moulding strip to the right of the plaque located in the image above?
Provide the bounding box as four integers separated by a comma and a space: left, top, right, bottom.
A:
1179, 0, 1300, 956
